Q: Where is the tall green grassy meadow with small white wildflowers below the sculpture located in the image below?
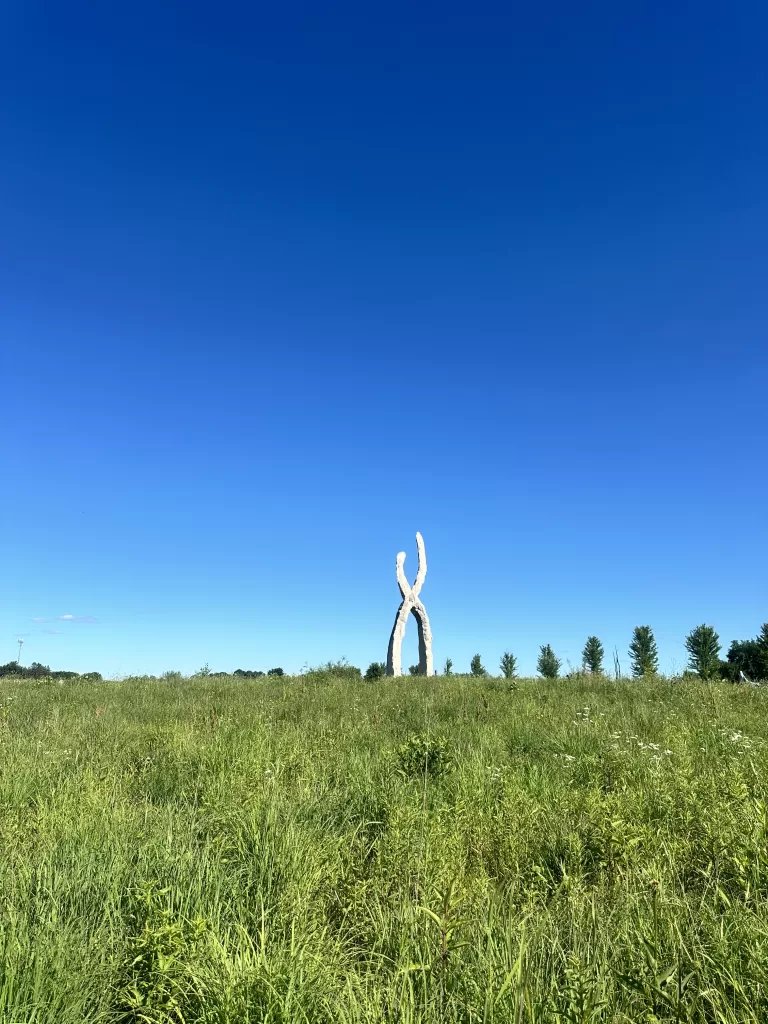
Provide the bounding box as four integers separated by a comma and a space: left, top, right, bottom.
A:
0, 677, 768, 1024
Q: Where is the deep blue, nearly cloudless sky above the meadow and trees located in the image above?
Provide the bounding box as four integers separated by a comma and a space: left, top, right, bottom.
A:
0, 0, 768, 675
